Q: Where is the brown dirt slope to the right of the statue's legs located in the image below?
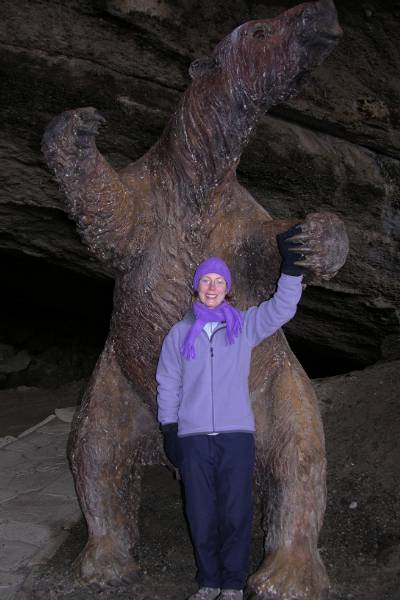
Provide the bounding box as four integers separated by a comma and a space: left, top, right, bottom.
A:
314, 361, 400, 600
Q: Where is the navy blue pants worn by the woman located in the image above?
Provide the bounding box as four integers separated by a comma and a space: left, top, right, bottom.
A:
179, 433, 255, 589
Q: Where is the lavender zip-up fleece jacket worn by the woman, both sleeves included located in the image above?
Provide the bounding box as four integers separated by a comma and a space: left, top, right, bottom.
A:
156, 274, 303, 436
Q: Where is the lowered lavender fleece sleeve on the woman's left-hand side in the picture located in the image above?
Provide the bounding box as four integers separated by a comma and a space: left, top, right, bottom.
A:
156, 330, 182, 425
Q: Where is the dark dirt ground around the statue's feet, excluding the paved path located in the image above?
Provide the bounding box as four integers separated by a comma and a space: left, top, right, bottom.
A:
21, 361, 400, 600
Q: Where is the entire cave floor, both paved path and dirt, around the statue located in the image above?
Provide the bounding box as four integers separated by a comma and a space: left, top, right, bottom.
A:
0, 361, 400, 600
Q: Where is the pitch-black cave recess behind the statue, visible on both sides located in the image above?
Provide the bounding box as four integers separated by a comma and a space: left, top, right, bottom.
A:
0, 251, 372, 435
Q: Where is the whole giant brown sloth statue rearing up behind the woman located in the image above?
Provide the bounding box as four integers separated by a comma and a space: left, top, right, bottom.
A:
43, 0, 348, 600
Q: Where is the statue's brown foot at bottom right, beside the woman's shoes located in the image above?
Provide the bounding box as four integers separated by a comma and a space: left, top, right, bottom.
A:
248, 546, 329, 600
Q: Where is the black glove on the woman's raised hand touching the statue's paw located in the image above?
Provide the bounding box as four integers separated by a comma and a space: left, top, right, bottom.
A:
276, 224, 310, 276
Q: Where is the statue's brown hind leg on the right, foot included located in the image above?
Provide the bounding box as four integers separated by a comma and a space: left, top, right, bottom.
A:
249, 332, 329, 600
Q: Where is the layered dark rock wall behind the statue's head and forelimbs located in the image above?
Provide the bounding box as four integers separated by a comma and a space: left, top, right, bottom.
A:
0, 0, 400, 374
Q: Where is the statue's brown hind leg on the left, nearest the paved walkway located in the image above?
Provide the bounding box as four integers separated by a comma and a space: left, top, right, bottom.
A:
69, 343, 159, 586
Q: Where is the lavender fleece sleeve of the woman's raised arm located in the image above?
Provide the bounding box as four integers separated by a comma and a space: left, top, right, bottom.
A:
244, 274, 303, 346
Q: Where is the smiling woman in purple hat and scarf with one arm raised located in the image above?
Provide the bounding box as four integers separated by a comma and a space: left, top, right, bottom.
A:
157, 226, 304, 600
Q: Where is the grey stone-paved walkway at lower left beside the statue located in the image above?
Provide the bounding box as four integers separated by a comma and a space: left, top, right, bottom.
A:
0, 407, 81, 600
